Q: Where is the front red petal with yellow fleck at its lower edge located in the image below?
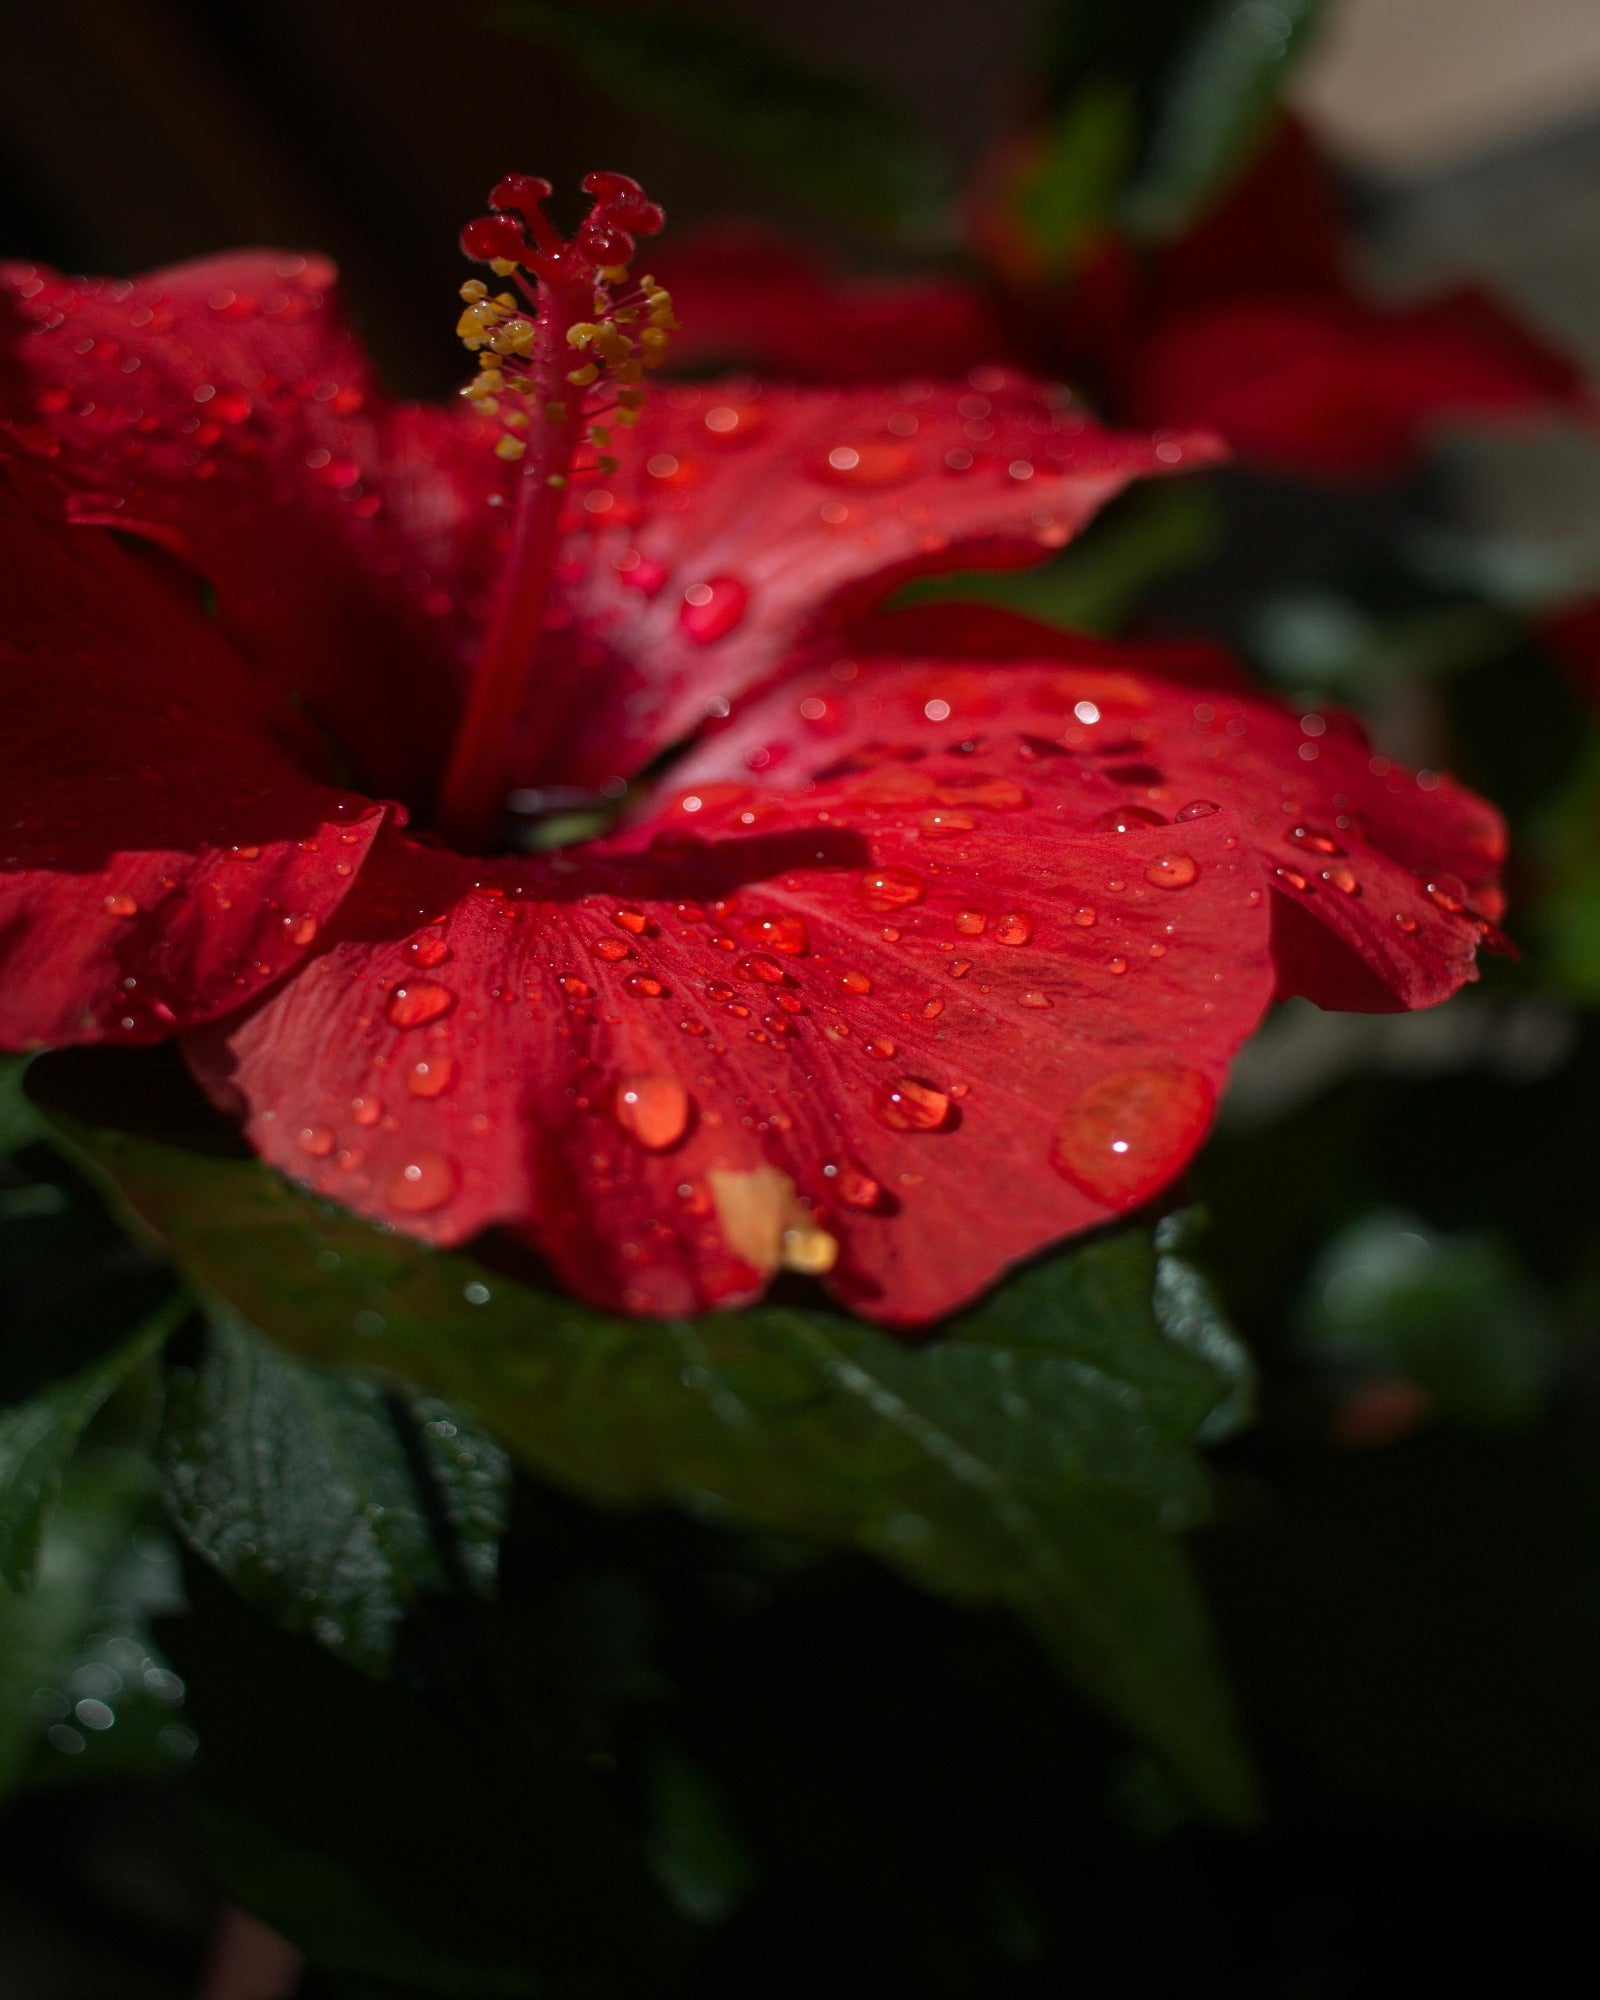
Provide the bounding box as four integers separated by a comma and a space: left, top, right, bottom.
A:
188, 780, 1272, 1322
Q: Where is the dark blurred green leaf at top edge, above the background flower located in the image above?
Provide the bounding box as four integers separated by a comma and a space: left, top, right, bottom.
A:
502, 0, 954, 248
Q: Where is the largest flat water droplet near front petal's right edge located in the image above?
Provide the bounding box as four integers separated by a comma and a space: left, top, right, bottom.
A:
1050, 1068, 1214, 1208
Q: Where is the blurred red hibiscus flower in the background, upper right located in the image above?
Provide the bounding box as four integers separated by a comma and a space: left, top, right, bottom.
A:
668, 120, 1586, 478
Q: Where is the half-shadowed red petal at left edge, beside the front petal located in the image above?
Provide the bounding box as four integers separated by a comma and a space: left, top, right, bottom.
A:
0, 468, 384, 1048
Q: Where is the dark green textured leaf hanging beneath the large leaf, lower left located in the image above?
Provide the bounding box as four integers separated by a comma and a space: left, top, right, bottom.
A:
158, 1308, 510, 1674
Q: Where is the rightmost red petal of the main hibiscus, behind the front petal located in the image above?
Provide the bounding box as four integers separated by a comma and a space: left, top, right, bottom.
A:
656, 640, 1506, 1012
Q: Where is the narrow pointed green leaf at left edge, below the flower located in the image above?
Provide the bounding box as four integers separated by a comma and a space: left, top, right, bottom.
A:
0, 1298, 192, 1588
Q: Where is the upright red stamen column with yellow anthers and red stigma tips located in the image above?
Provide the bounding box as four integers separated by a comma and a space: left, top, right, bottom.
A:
438, 174, 676, 850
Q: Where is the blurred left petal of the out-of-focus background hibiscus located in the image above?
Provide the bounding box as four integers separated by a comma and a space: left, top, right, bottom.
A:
652, 228, 1010, 382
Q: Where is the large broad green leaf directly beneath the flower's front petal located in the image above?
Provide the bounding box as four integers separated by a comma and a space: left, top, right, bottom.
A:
21, 1054, 1252, 1818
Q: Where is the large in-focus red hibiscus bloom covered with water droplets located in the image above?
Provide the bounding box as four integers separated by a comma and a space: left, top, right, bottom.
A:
0, 176, 1500, 1322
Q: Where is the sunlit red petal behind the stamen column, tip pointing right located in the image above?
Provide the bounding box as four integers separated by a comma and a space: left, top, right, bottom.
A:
520, 368, 1218, 784
